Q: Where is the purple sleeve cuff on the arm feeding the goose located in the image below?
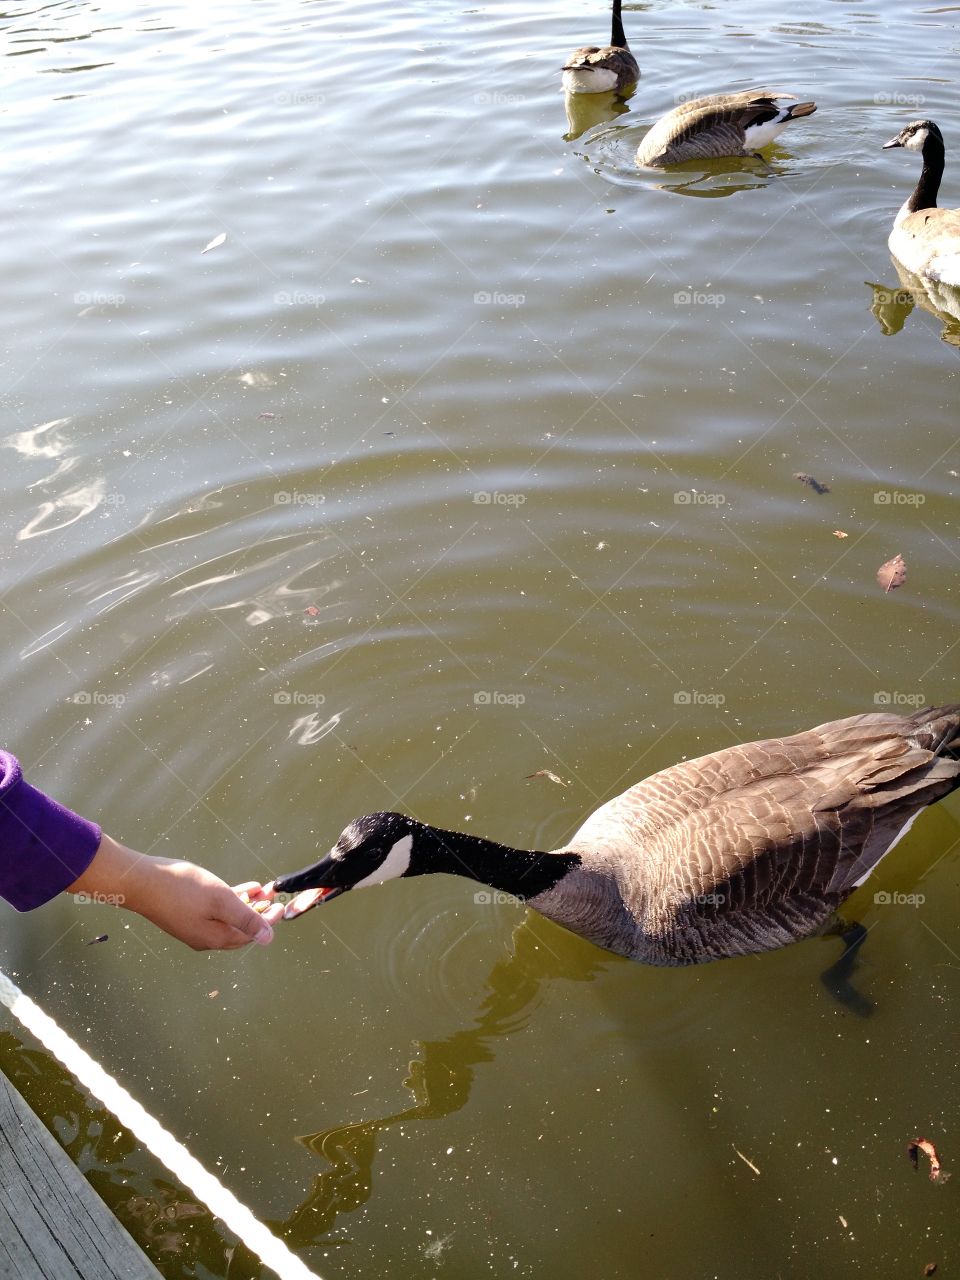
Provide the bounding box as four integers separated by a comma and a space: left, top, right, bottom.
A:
0, 751, 101, 911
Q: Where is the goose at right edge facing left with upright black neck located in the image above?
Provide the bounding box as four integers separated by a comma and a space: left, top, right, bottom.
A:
883, 120, 960, 284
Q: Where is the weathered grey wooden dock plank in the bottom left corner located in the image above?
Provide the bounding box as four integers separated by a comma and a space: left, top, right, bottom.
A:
0, 1074, 161, 1280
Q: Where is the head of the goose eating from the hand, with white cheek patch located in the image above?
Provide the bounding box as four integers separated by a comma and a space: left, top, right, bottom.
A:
273, 813, 417, 918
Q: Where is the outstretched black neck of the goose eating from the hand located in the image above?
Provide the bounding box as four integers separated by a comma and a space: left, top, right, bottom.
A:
407, 824, 580, 899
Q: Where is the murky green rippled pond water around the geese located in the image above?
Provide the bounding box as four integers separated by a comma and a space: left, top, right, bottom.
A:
0, 0, 960, 1280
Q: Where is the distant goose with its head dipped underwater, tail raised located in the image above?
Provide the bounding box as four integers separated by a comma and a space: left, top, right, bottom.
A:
636, 88, 817, 169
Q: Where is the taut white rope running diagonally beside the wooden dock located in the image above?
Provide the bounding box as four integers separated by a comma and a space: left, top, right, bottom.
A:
0, 972, 320, 1280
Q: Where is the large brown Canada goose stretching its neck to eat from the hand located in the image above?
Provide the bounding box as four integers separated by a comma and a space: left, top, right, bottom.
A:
272, 705, 960, 965
